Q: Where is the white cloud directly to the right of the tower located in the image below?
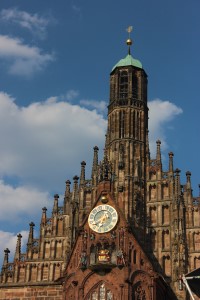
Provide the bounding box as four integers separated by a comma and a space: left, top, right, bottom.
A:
148, 99, 183, 154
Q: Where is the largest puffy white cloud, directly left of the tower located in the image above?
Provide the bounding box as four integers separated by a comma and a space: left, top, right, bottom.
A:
0, 93, 107, 192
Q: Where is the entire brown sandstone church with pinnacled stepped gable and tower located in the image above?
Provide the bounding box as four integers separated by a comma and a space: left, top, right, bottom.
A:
0, 39, 200, 300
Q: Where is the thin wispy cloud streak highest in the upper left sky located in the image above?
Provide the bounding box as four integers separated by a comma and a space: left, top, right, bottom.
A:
0, 8, 53, 39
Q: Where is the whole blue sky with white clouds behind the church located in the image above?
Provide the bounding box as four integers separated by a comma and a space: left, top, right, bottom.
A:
0, 0, 200, 264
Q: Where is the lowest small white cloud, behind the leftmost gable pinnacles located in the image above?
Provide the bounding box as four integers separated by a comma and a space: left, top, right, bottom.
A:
0, 230, 29, 266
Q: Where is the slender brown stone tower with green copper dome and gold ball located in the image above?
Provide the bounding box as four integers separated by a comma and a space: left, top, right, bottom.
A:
106, 30, 149, 237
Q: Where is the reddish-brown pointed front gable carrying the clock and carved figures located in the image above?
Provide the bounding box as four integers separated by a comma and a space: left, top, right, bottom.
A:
64, 192, 173, 300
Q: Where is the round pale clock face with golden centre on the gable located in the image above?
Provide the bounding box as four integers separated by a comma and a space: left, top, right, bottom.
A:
88, 205, 118, 233
